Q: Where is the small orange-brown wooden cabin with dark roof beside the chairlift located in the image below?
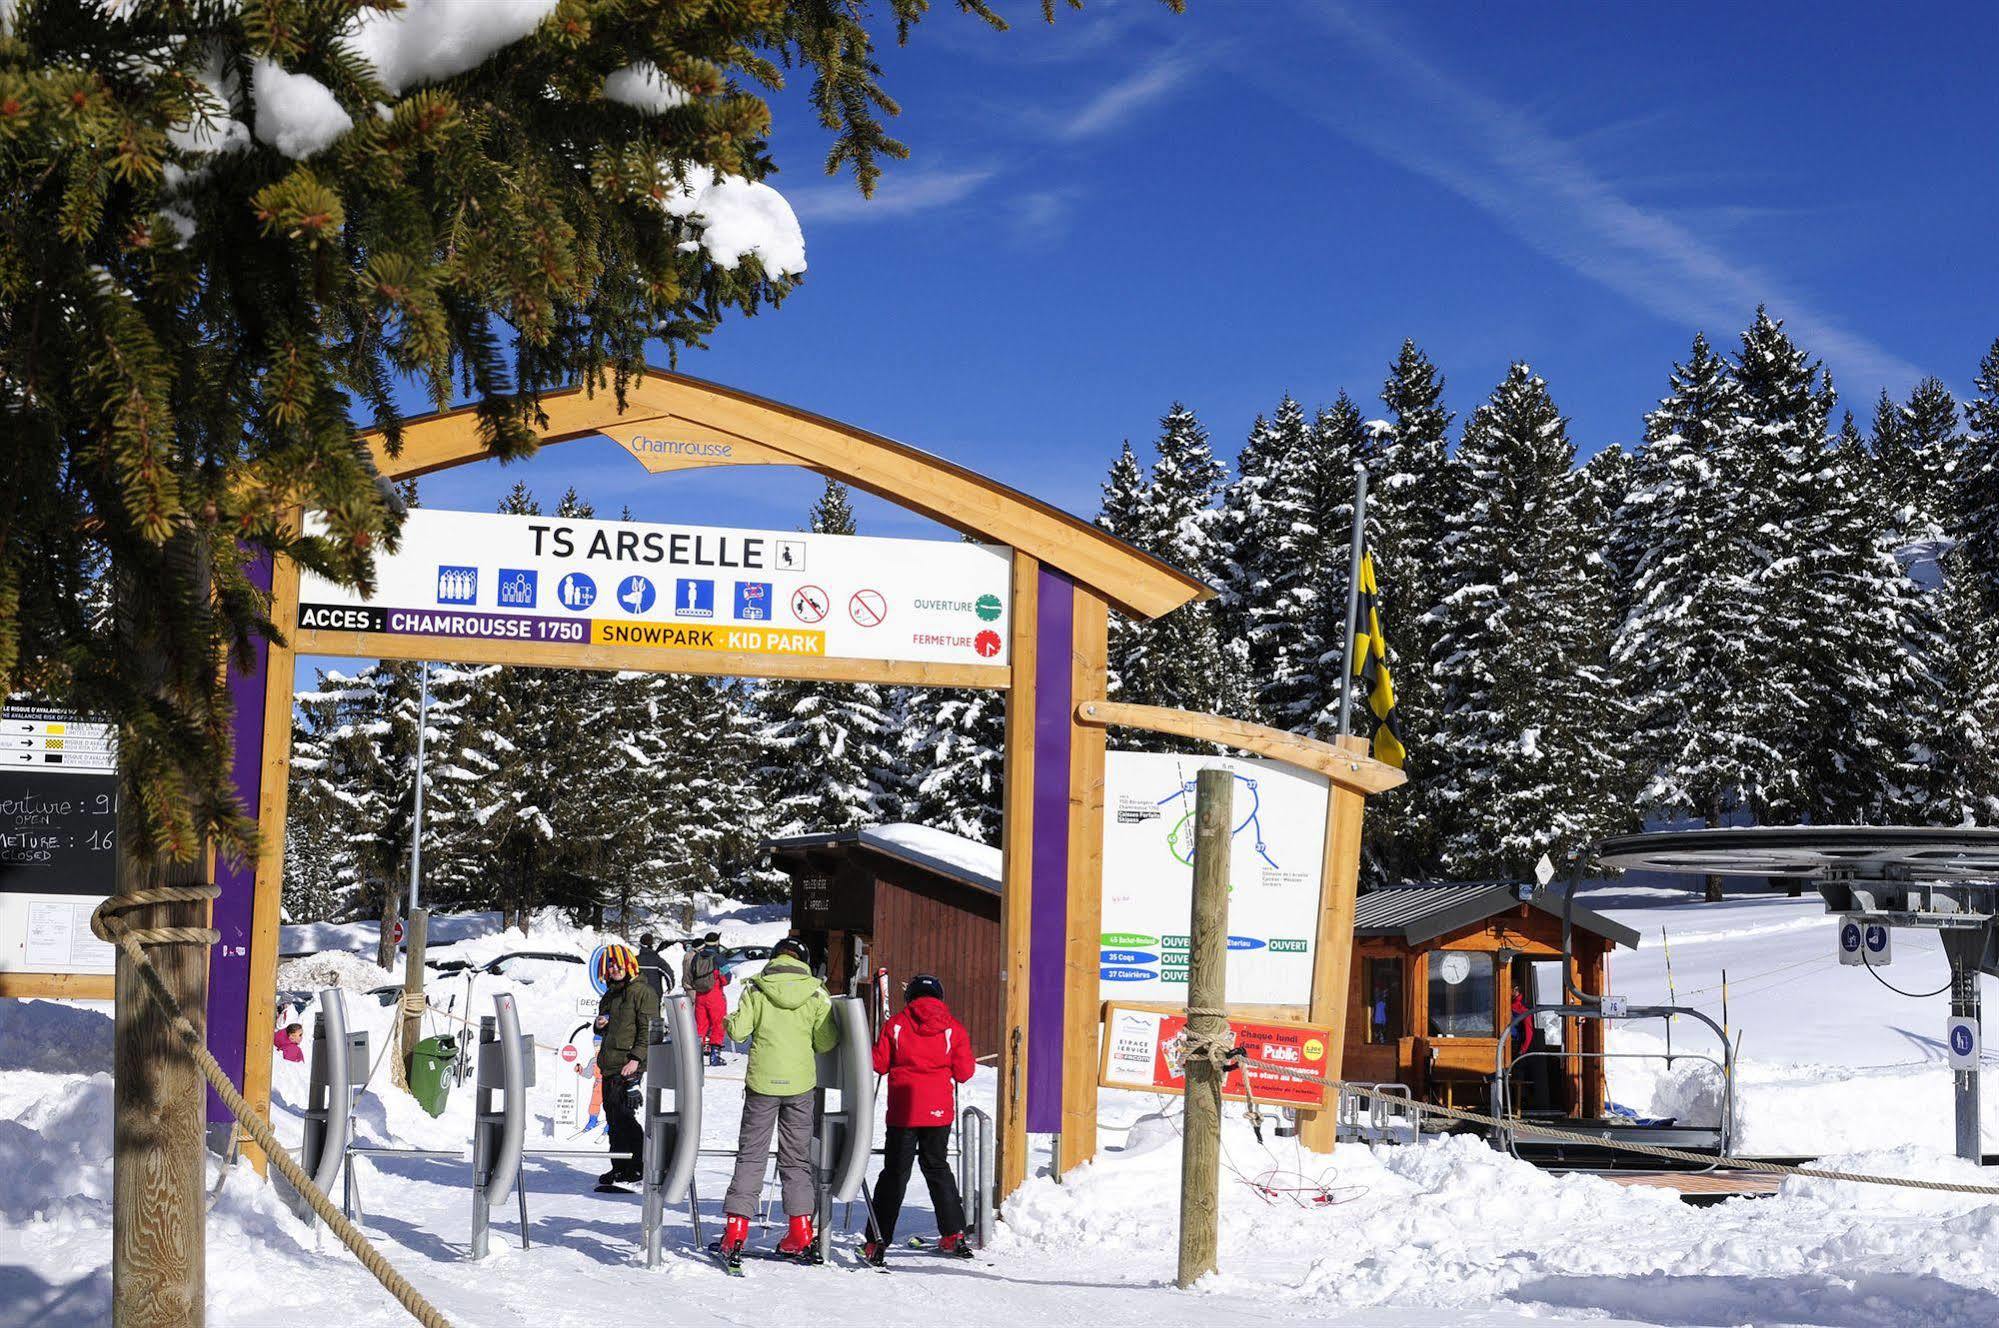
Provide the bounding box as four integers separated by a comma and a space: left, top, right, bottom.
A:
1341, 882, 1639, 1118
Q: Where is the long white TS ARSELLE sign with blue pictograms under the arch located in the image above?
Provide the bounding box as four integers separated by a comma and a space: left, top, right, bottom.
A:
298, 508, 1011, 664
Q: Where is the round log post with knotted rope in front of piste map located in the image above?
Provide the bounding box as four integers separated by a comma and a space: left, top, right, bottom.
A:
1177, 770, 1235, 1288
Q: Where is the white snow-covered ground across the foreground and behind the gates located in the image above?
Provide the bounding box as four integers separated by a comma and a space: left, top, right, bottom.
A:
0, 888, 1999, 1328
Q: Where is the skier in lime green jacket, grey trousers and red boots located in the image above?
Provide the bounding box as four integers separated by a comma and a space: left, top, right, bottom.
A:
722, 936, 840, 1260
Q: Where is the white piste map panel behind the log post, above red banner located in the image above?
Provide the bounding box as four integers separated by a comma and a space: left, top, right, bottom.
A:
1097, 752, 1327, 1006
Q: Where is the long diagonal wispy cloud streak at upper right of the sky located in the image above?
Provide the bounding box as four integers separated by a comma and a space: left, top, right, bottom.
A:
1293, 4, 1923, 388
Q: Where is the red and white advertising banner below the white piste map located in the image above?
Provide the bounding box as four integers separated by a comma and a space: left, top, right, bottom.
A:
1097, 1002, 1337, 1106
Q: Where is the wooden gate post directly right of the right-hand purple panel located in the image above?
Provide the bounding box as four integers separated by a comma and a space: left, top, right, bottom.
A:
1057, 586, 1109, 1174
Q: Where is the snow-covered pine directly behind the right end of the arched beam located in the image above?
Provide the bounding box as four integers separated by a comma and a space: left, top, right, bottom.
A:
1097, 402, 1253, 750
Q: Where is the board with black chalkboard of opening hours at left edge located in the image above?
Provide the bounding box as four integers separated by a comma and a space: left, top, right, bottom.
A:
0, 706, 118, 974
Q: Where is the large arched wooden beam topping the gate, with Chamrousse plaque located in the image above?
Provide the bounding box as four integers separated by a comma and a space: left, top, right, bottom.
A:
362, 368, 1213, 618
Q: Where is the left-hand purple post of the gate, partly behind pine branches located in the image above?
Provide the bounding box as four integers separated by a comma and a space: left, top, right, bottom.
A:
208, 552, 275, 1124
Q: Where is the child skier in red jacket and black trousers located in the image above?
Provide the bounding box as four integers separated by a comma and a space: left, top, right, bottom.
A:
862, 974, 974, 1264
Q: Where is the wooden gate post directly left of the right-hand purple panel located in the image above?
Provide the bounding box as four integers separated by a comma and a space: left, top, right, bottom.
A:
994, 552, 1041, 1202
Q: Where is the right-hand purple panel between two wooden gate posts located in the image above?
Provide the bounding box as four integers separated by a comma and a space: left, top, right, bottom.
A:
1027, 564, 1075, 1134
